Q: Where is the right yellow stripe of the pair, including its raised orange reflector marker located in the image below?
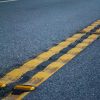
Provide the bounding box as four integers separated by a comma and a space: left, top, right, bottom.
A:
4, 34, 99, 100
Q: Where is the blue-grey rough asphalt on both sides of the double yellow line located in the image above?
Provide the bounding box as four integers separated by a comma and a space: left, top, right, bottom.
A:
0, 0, 100, 100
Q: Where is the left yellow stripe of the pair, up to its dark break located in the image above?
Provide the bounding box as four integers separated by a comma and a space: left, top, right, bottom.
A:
0, 33, 85, 87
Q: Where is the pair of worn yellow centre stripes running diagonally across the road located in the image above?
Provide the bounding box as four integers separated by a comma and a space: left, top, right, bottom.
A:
0, 20, 100, 100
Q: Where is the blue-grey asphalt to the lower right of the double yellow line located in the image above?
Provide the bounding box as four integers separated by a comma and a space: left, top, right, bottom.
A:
24, 39, 100, 100
